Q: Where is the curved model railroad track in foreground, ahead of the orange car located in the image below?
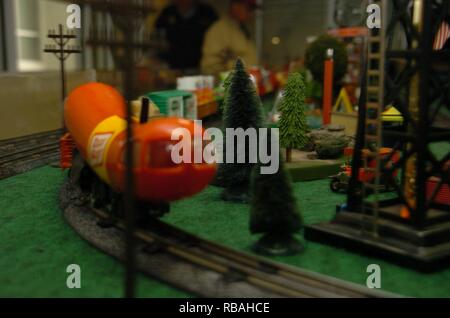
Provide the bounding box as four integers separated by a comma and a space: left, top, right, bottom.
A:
93, 209, 398, 298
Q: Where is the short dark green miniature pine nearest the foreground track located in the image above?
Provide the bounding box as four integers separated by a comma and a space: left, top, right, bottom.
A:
250, 153, 303, 255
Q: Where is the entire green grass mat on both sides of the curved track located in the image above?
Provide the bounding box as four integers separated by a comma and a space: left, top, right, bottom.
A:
0, 167, 450, 297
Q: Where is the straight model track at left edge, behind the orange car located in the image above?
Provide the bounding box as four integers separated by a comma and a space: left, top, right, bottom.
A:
0, 129, 62, 179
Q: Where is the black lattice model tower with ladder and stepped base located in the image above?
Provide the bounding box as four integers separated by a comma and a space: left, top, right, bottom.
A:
305, 0, 450, 271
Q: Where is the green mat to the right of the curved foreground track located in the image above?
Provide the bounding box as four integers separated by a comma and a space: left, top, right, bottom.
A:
165, 185, 450, 297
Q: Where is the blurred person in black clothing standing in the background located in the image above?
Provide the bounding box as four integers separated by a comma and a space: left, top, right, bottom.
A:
155, 0, 218, 73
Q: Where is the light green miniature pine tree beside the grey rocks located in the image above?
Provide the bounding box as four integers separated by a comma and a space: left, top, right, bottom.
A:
278, 73, 308, 162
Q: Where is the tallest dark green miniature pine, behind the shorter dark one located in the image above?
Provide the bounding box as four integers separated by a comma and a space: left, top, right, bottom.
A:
216, 59, 262, 202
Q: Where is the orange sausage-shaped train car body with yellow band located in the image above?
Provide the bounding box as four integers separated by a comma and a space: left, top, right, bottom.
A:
64, 83, 216, 202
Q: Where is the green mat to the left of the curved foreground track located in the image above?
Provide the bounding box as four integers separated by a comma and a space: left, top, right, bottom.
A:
0, 167, 189, 297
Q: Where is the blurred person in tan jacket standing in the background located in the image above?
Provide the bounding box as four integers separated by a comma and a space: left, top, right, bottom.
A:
201, 0, 258, 75
